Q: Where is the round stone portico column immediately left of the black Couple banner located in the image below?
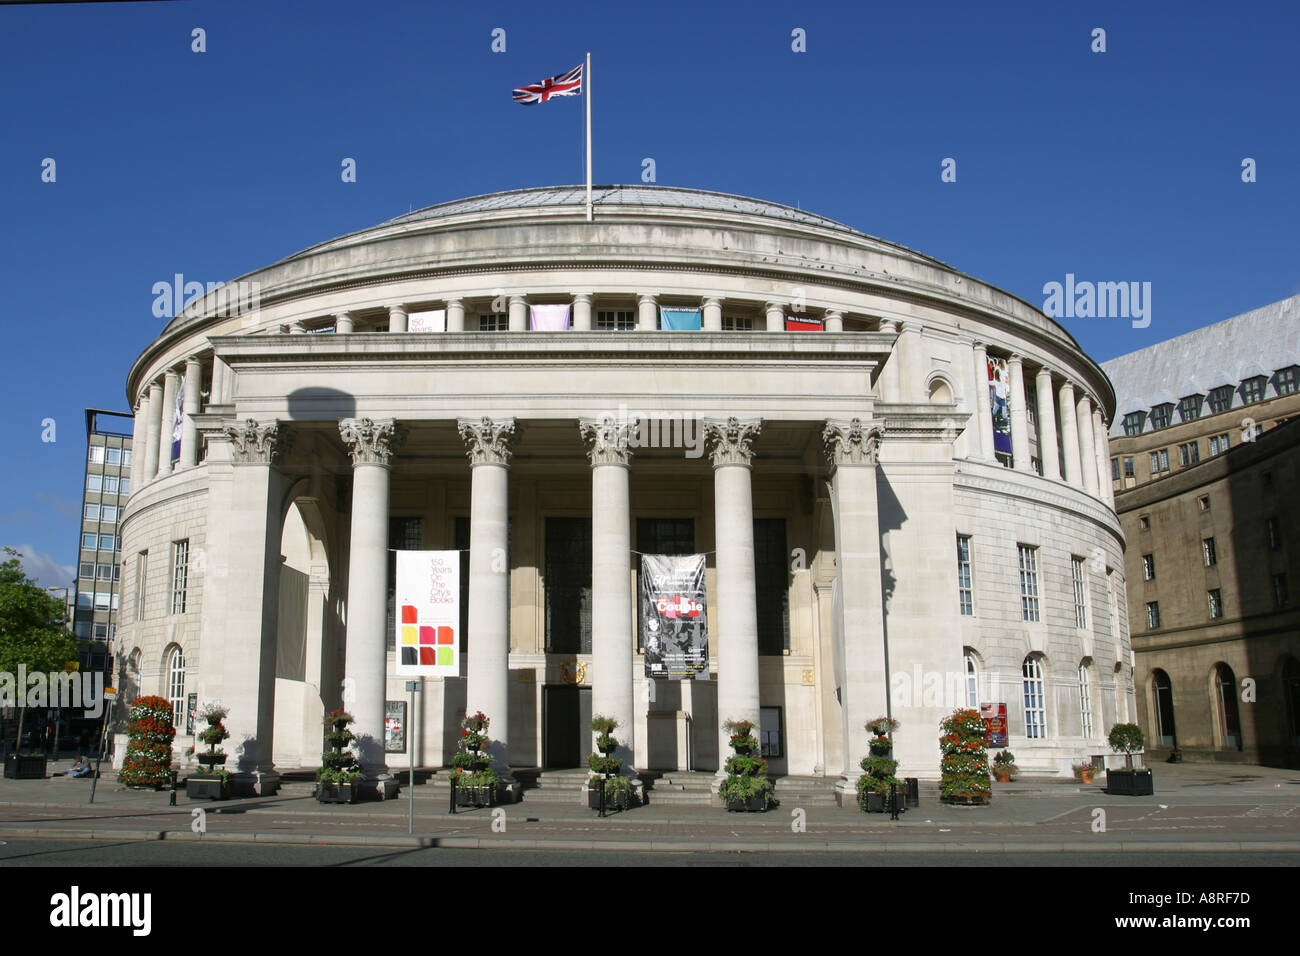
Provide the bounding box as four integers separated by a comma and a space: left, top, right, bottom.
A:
582, 418, 637, 775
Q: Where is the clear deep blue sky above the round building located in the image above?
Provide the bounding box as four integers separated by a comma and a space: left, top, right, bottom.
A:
0, 0, 1300, 585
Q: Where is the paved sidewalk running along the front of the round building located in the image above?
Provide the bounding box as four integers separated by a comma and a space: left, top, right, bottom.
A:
0, 763, 1300, 853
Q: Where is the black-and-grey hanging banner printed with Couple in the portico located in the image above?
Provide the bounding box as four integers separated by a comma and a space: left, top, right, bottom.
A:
641, 554, 709, 680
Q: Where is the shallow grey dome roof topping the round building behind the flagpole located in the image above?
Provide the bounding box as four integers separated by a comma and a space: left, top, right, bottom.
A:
384, 186, 862, 235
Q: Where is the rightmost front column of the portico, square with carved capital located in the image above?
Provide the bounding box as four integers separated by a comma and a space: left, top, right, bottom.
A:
822, 419, 889, 806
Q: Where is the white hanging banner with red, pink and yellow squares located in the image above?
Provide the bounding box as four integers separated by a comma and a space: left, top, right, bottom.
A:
395, 551, 460, 678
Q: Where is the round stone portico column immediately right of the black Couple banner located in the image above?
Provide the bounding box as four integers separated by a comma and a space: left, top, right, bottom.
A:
703, 418, 763, 787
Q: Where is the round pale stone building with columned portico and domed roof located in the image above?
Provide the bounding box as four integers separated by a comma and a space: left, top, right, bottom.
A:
116, 186, 1135, 795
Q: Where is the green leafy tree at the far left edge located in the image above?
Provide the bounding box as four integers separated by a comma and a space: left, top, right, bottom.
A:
0, 548, 77, 744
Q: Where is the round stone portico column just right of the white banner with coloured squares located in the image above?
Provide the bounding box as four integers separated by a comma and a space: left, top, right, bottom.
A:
456, 418, 519, 787
